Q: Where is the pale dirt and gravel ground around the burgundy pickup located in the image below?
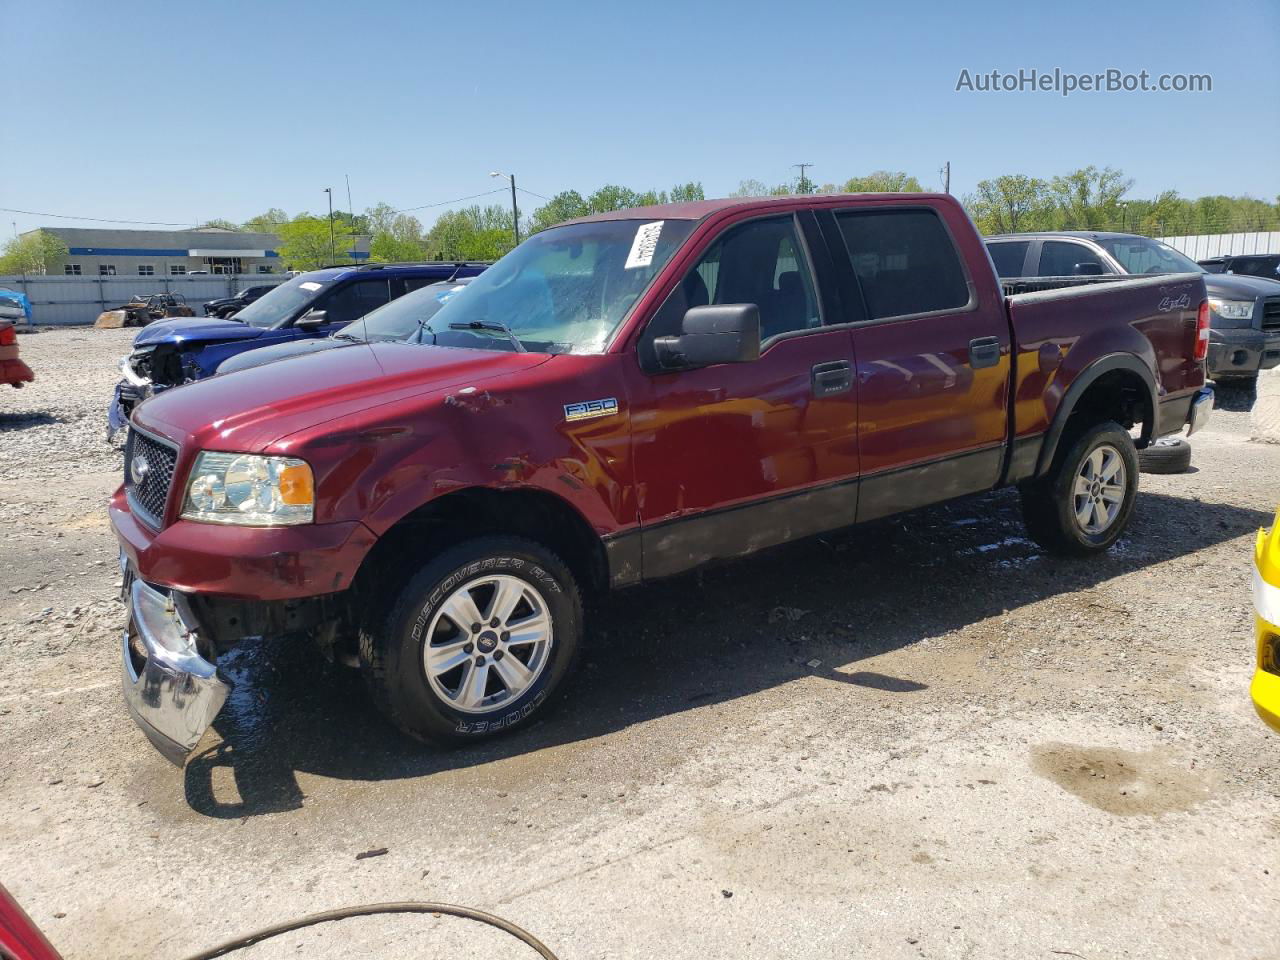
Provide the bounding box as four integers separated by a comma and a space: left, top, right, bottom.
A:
0, 329, 1280, 960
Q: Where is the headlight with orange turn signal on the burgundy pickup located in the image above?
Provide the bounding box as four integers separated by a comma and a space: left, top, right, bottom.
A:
182, 451, 316, 526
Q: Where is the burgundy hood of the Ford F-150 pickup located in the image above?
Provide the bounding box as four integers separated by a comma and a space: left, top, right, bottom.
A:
133, 342, 550, 453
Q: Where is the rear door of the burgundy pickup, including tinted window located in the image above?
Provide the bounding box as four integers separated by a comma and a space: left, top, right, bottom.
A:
822, 204, 1010, 521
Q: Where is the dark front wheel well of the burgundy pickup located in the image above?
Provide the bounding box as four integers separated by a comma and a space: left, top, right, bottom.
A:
355, 488, 608, 611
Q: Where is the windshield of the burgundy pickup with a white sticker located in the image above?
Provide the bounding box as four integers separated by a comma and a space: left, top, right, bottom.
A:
424, 220, 694, 353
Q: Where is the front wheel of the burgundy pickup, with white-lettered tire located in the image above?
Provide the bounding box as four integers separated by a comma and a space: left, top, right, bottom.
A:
360, 536, 582, 744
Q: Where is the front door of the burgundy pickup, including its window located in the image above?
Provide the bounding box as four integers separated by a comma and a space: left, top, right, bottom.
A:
631, 214, 858, 579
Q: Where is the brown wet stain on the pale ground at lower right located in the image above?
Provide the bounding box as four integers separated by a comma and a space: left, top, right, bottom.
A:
1032, 744, 1211, 817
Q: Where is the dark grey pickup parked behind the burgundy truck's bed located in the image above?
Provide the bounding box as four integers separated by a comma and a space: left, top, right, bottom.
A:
987, 230, 1280, 380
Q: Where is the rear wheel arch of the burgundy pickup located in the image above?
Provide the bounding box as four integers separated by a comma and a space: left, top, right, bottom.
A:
1036, 353, 1160, 476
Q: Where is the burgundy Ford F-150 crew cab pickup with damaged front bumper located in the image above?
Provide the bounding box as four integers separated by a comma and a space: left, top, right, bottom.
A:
110, 195, 1212, 763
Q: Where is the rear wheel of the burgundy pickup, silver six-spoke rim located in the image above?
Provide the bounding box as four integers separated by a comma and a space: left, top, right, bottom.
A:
1020, 421, 1138, 557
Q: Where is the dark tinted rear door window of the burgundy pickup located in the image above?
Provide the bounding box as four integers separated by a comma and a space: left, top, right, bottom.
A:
836, 210, 969, 319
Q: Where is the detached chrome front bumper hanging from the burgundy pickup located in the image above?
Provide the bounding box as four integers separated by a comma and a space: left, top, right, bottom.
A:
123, 580, 230, 767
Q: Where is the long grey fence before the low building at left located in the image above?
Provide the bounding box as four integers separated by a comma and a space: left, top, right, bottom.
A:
0, 274, 289, 324
